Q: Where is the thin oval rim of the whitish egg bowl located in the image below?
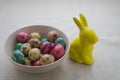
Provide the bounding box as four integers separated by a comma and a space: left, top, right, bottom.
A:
4, 25, 70, 68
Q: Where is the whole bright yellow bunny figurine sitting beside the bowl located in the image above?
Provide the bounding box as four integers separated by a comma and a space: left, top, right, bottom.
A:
68, 14, 98, 64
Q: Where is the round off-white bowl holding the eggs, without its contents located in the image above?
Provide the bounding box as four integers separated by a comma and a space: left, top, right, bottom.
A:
5, 25, 70, 73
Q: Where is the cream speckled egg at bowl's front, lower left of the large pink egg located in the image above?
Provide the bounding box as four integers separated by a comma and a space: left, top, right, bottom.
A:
40, 54, 55, 65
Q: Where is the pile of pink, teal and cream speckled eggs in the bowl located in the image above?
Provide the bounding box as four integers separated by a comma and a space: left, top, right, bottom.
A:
12, 31, 66, 66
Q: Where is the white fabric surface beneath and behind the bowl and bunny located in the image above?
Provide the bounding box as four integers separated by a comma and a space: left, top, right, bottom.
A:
0, 0, 120, 80
